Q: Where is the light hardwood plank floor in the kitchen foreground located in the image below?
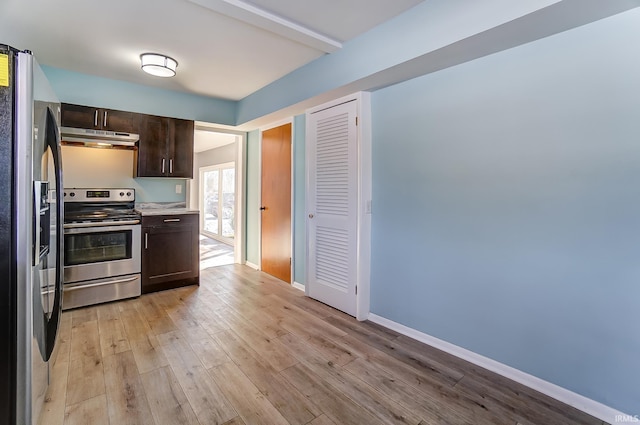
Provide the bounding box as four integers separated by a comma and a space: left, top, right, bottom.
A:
41, 265, 602, 425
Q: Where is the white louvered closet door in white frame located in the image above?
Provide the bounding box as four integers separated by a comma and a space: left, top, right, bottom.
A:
307, 101, 358, 316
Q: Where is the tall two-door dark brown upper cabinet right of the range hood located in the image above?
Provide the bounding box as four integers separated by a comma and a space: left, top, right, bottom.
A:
136, 115, 194, 179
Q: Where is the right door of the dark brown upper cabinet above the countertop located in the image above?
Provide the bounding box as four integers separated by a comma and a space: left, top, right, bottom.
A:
168, 119, 194, 179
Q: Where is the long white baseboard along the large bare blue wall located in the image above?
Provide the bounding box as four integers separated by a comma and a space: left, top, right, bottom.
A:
369, 313, 631, 423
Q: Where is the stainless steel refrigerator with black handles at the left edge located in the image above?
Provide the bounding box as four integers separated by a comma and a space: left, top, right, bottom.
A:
0, 44, 64, 425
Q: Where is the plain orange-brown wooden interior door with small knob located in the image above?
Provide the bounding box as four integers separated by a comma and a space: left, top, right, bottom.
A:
261, 124, 291, 283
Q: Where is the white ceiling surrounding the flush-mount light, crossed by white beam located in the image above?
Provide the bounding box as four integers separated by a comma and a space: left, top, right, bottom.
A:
0, 0, 423, 100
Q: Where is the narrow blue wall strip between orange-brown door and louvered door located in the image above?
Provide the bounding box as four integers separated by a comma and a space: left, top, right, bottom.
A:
293, 115, 307, 285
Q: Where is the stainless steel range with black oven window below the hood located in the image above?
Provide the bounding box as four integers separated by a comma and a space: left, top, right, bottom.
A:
62, 188, 141, 310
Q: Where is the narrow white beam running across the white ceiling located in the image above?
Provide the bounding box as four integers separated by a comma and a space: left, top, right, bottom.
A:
189, 0, 342, 53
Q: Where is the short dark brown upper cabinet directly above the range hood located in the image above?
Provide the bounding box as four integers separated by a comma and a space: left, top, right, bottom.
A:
61, 103, 140, 133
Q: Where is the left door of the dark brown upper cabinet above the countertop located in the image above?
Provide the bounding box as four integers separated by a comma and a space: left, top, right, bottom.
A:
136, 115, 169, 177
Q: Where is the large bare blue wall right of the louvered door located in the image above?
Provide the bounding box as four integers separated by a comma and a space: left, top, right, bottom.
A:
371, 10, 640, 412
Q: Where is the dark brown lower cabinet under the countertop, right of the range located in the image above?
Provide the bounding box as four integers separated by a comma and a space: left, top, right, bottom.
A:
142, 214, 200, 294
